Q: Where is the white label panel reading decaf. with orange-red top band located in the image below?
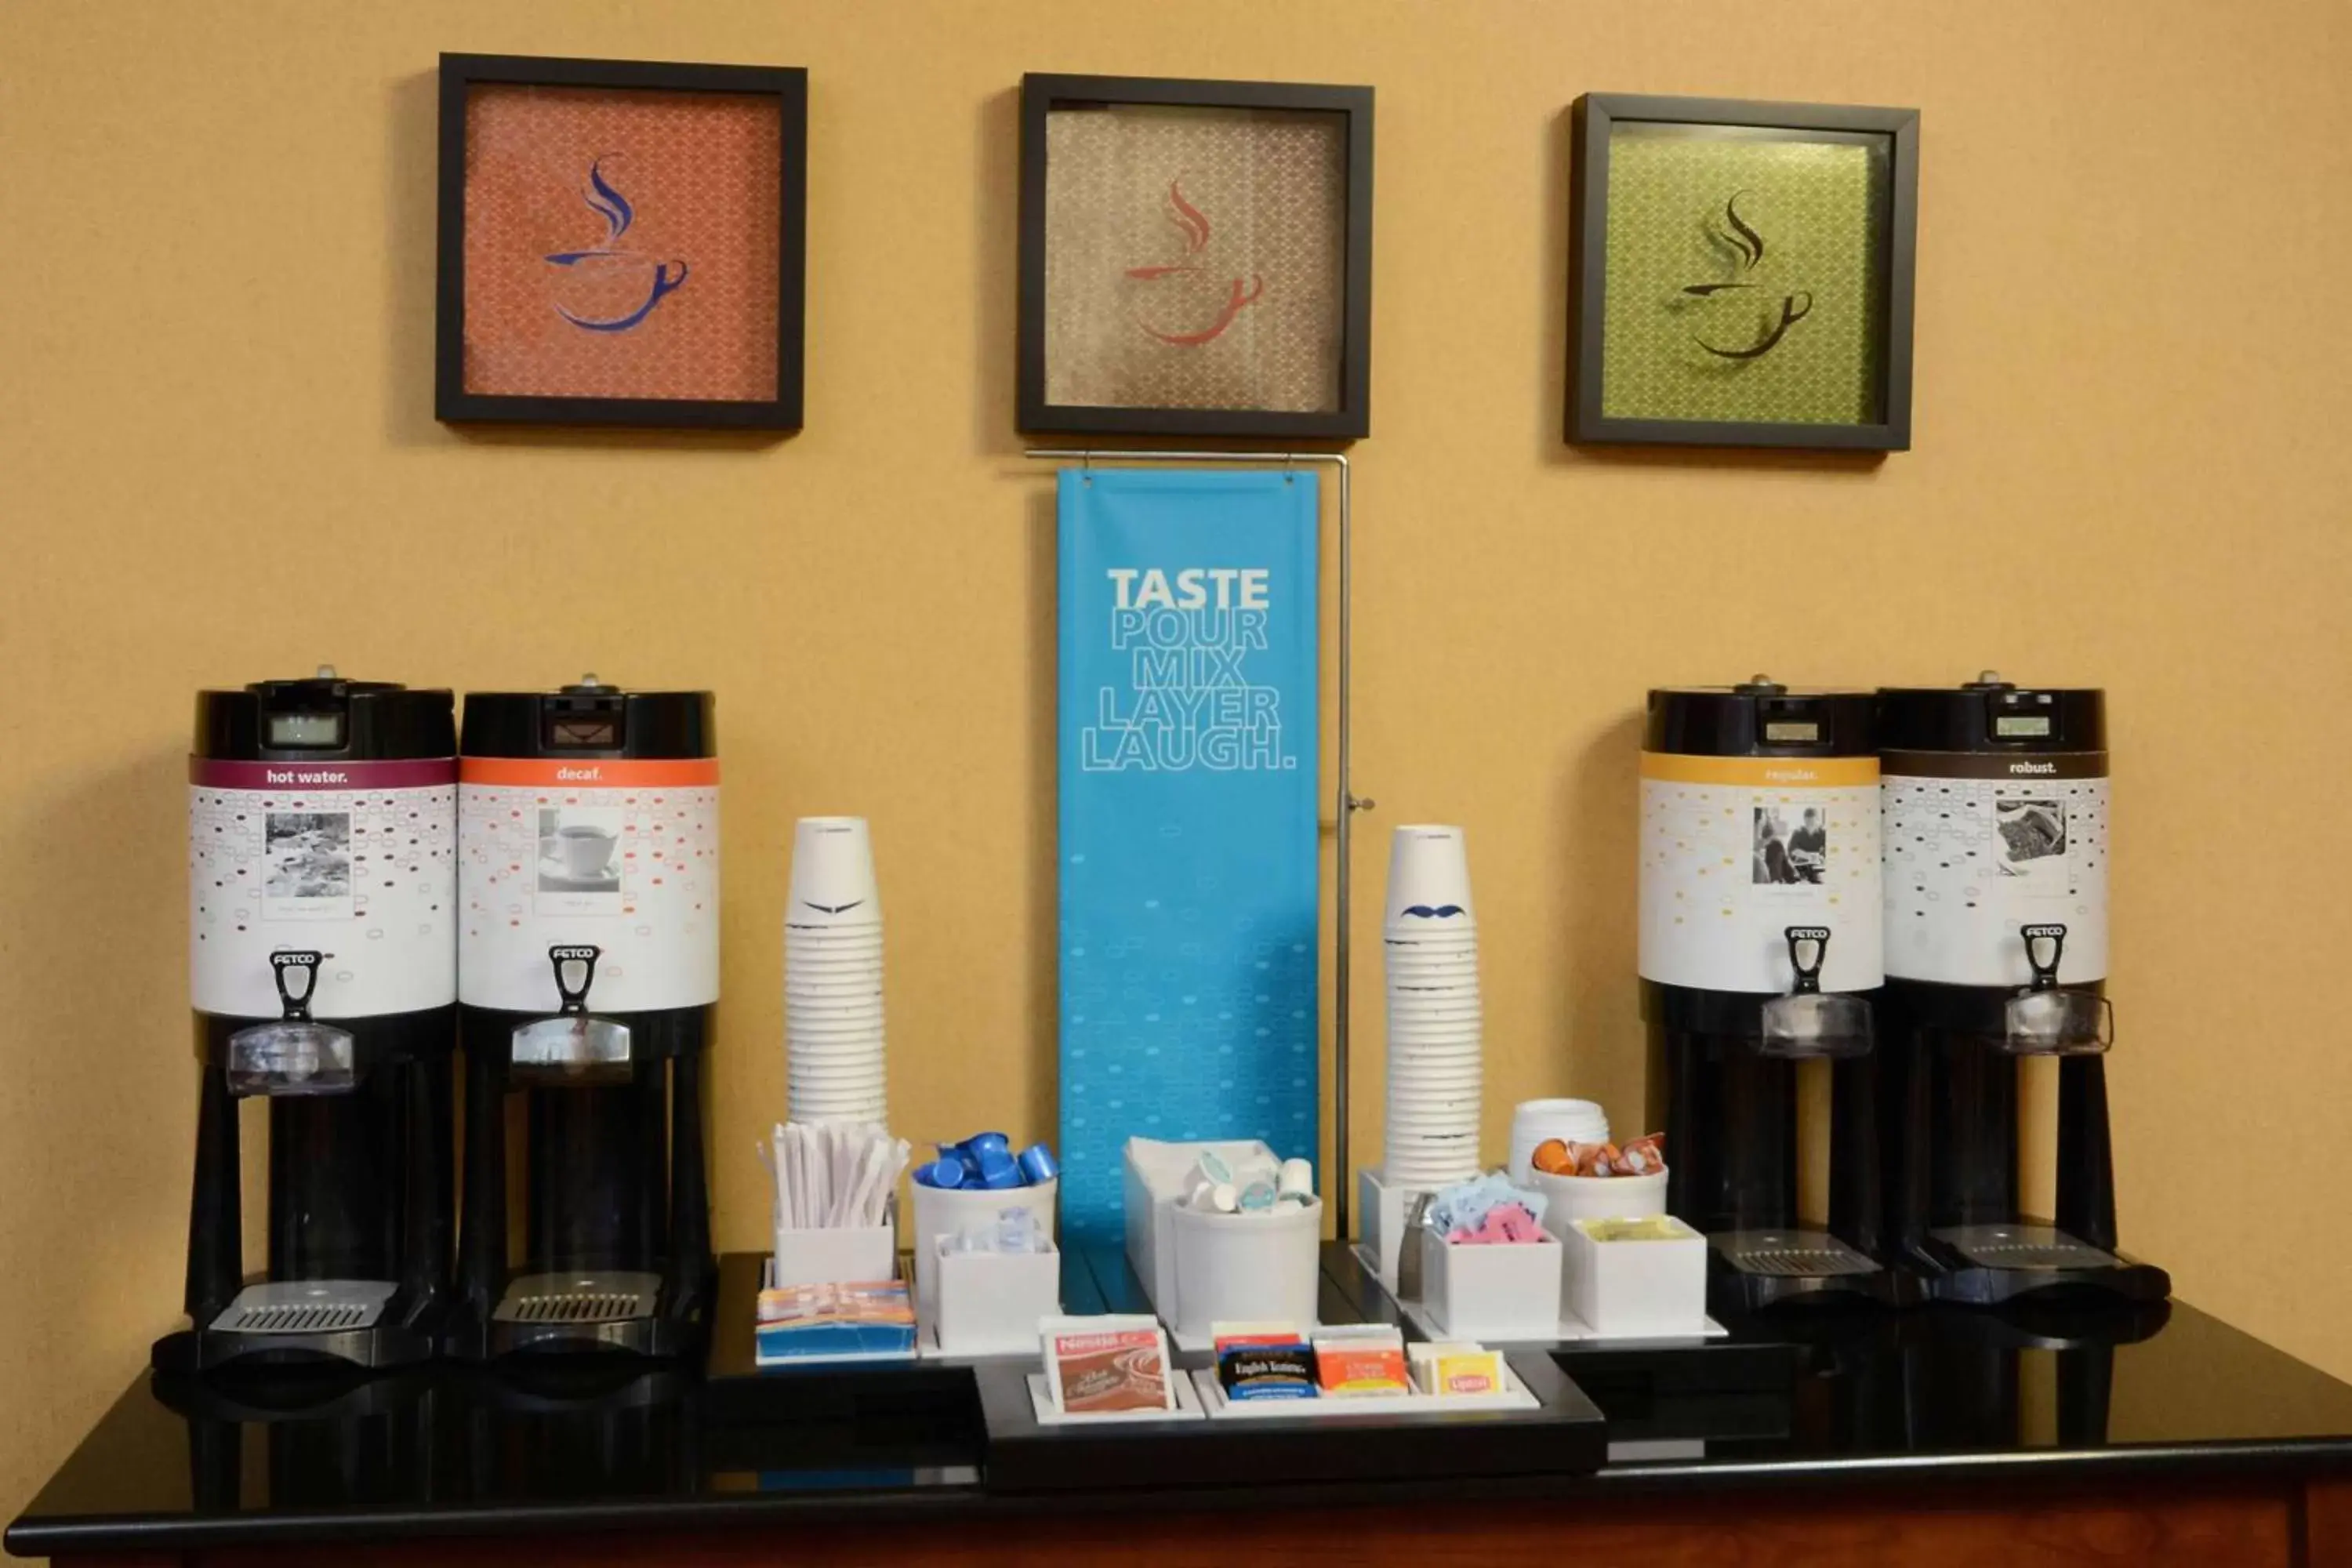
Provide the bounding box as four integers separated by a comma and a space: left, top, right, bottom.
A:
459, 757, 720, 1013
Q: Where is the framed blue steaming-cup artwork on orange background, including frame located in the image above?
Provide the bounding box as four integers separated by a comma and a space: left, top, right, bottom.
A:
433, 54, 809, 430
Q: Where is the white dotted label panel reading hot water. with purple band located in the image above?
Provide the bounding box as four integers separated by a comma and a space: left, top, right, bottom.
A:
188, 757, 456, 1018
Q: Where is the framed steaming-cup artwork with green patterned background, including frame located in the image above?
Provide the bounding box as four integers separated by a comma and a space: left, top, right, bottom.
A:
1569, 92, 1919, 452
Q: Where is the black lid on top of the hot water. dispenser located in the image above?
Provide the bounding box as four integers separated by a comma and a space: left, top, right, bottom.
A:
193, 666, 456, 762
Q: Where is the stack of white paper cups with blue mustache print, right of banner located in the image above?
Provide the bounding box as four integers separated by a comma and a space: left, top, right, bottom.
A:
1381, 825, 1484, 1187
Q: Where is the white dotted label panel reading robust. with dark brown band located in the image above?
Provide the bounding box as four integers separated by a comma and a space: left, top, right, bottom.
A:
1884, 753, 2107, 985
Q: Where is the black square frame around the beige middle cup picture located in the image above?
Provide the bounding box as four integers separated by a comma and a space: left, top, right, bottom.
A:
1014, 73, 1371, 440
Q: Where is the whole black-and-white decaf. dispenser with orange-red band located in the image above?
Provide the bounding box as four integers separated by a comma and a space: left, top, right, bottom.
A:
449, 675, 720, 1359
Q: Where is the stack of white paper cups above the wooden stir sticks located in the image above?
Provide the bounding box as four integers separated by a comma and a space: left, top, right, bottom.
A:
783, 815, 889, 1126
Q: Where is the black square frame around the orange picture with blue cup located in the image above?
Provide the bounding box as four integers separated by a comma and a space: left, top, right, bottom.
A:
433, 54, 809, 430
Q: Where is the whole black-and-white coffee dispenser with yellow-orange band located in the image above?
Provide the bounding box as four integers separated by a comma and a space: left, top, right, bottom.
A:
1642, 675, 1910, 1312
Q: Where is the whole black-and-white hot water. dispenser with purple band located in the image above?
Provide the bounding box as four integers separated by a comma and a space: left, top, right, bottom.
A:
153, 668, 456, 1373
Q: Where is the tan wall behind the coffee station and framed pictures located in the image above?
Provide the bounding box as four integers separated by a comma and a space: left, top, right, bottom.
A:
0, 0, 2352, 1509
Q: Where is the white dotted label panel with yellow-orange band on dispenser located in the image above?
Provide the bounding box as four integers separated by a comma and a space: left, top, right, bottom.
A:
1642, 753, 1884, 994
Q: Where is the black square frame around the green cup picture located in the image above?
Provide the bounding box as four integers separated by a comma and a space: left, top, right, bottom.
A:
1566, 92, 1919, 452
